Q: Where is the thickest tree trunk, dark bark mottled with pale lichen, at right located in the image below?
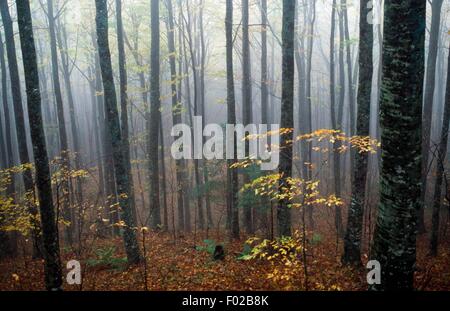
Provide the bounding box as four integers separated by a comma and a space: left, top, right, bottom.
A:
371, 0, 426, 290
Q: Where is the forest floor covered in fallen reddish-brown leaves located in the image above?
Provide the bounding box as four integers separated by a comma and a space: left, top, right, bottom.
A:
0, 227, 450, 291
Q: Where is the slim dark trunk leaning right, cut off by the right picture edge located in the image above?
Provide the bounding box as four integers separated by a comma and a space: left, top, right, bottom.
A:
430, 40, 450, 256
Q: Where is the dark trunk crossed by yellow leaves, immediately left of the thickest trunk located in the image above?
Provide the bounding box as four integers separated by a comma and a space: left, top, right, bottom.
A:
342, 0, 373, 265
